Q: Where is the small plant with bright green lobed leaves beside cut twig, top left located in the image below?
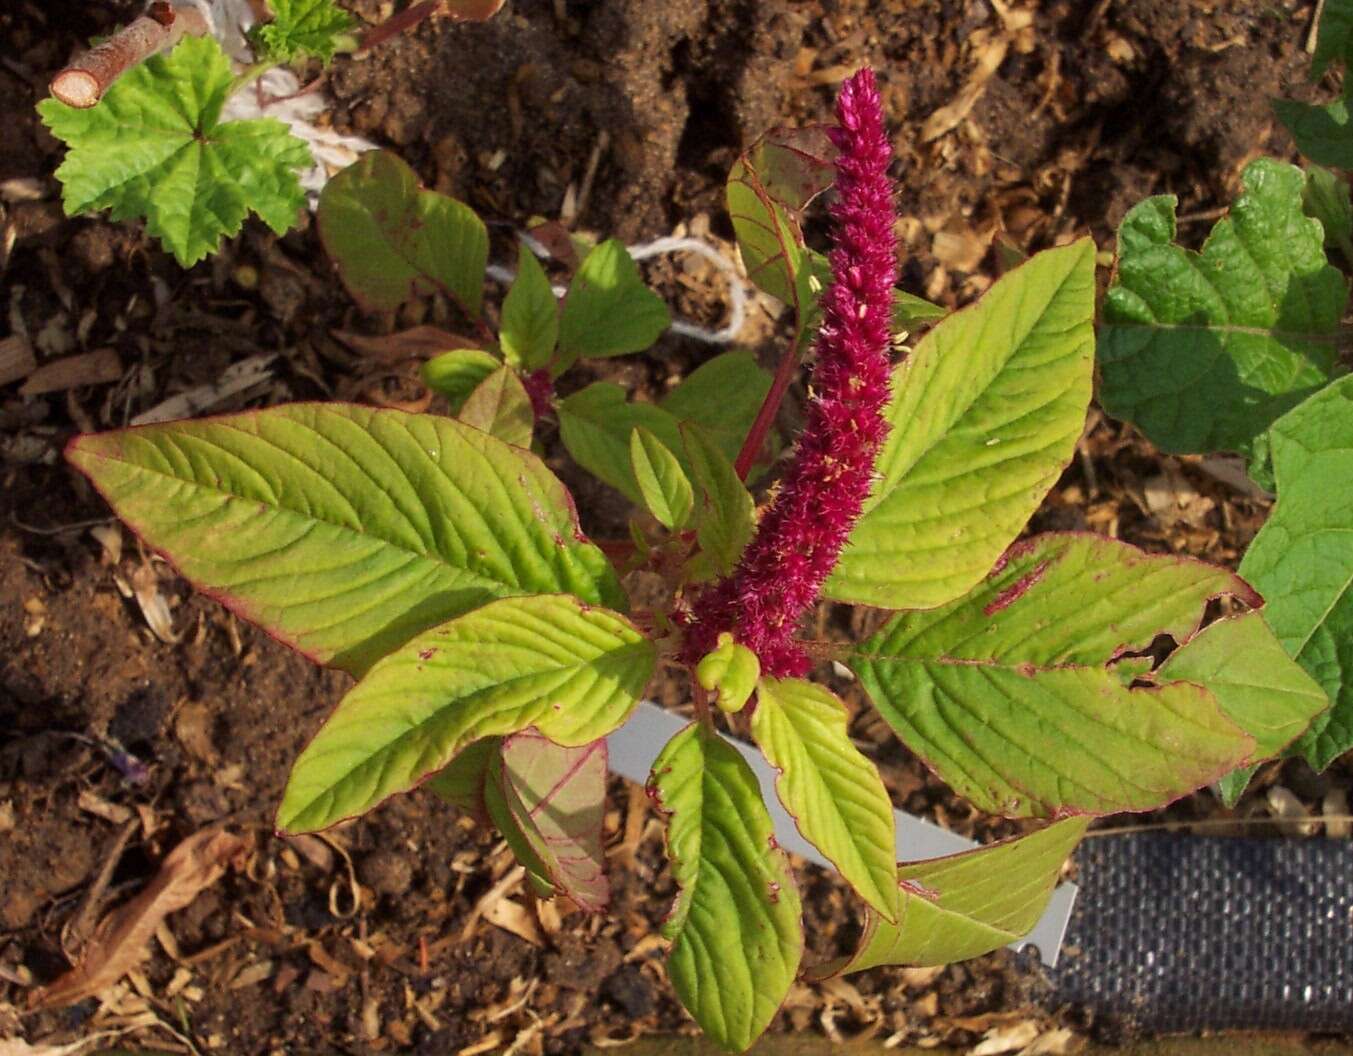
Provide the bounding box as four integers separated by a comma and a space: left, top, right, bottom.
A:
38, 0, 501, 267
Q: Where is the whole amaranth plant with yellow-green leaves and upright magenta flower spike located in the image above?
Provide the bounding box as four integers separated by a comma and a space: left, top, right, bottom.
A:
68, 70, 1342, 1051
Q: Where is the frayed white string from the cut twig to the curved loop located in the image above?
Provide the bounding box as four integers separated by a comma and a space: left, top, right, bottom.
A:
175, 0, 747, 345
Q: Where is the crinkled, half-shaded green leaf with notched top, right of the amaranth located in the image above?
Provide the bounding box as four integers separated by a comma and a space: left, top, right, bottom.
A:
1099, 158, 1348, 452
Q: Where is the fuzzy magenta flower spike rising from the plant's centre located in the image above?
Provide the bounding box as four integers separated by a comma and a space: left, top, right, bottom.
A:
683, 69, 897, 677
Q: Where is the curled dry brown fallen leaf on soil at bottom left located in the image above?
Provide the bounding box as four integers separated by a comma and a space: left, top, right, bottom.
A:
28, 829, 246, 1009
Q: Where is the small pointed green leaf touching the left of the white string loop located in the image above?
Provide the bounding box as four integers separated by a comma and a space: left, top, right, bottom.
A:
552, 238, 671, 376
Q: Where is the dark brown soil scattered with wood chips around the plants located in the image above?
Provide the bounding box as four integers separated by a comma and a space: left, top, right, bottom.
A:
0, 0, 1348, 1056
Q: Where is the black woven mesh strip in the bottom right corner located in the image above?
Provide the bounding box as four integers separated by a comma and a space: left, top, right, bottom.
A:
1051, 833, 1353, 1032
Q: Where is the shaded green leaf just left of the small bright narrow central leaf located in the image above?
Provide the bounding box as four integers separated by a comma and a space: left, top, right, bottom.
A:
555, 382, 685, 505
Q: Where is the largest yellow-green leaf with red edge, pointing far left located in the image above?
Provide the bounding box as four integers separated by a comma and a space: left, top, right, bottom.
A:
68, 403, 625, 674
